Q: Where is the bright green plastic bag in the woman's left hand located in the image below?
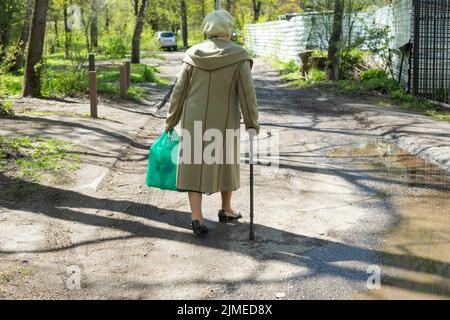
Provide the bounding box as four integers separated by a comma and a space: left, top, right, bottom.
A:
146, 129, 180, 191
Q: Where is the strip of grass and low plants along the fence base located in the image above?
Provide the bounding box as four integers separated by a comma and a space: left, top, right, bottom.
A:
268, 57, 450, 122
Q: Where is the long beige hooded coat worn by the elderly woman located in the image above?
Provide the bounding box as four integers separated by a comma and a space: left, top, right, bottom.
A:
165, 38, 259, 193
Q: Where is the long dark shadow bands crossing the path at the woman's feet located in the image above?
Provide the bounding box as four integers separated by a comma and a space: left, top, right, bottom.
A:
0, 174, 449, 295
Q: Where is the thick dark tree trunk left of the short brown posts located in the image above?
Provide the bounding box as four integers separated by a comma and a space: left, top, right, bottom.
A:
23, 0, 49, 97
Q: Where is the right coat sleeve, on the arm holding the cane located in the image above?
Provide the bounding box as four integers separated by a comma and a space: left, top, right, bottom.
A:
238, 60, 259, 134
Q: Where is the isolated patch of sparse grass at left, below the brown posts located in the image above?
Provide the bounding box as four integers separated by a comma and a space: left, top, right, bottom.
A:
0, 137, 80, 180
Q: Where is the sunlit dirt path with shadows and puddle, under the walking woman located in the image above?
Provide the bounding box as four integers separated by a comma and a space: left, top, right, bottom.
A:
0, 53, 450, 299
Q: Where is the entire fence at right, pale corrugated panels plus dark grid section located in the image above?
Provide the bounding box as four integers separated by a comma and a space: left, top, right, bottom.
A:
245, 0, 450, 106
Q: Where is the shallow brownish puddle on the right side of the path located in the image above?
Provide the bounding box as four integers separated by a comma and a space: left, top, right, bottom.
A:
327, 140, 450, 299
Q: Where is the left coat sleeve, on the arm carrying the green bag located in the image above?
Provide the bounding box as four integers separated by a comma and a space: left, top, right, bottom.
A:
164, 63, 192, 131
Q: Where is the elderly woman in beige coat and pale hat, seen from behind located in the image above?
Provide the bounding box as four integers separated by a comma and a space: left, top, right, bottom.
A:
165, 10, 259, 235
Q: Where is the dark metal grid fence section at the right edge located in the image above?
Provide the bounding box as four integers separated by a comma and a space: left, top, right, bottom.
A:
412, 0, 450, 105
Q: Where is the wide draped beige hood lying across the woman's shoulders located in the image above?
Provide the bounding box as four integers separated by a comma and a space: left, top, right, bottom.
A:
183, 38, 253, 71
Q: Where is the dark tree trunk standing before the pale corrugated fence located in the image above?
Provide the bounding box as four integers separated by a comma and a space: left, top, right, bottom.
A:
327, 0, 344, 80
